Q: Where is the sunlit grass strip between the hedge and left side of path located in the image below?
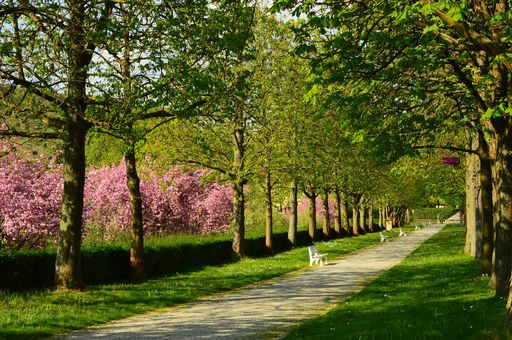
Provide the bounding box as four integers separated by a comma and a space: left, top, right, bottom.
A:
0, 226, 398, 339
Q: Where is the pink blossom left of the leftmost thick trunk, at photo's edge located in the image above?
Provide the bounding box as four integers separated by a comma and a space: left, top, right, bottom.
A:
0, 147, 63, 249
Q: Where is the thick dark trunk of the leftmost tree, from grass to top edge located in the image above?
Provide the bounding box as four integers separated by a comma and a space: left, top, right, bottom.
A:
55, 1, 93, 290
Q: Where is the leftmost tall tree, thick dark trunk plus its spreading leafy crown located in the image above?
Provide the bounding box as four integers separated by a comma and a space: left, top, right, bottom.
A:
0, 0, 258, 289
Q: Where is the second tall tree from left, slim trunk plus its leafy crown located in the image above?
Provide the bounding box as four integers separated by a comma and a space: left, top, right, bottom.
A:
90, 1, 231, 279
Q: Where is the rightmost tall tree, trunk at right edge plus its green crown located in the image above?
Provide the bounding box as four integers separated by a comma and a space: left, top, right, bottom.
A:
278, 0, 512, 294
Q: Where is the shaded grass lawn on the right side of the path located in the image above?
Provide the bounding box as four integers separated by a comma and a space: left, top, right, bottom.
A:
287, 226, 510, 339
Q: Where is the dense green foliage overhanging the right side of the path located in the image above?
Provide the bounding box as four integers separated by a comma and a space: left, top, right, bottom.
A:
274, 0, 500, 168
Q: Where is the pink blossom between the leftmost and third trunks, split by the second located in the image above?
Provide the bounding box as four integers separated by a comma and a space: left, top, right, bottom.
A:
84, 162, 231, 240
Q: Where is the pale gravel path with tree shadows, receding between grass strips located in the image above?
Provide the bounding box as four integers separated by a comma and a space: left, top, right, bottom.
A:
65, 224, 444, 339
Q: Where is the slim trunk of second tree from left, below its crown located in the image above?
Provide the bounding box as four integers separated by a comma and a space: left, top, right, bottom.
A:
125, 142, 145, 281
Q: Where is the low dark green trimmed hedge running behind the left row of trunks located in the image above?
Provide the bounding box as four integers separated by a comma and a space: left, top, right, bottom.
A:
0, 231, 320, 291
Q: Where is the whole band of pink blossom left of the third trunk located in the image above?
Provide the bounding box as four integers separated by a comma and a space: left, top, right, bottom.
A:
0, 145, 232, 249
